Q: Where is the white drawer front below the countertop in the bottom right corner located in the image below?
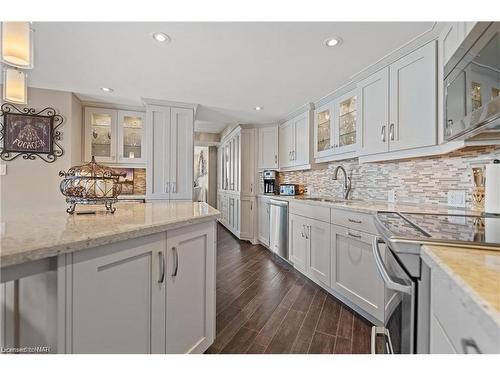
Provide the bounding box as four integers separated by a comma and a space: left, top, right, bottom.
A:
431, 270, 500, 354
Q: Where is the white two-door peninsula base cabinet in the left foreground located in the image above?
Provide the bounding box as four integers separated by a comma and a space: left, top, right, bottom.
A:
62, 222, 215, 354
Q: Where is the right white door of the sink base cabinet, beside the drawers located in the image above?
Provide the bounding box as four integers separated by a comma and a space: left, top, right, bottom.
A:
306, 220, 330, 286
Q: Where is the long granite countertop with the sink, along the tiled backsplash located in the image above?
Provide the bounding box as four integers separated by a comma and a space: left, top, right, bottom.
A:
259, 194, 481, 215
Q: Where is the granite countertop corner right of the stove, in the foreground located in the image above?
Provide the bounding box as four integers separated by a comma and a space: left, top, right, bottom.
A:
421, 245, 500, 326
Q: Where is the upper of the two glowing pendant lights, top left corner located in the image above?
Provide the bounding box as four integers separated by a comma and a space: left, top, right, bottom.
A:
2, 22, 33, 69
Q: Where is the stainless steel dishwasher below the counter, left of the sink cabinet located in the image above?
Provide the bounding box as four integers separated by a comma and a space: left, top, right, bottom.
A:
269, 199, 289, 262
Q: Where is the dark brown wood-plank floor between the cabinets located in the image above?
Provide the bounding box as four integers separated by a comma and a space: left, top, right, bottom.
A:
207, 224, 371, 354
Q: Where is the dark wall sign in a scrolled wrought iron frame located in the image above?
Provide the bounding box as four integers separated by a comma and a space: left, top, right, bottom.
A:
0, 103, 64, 163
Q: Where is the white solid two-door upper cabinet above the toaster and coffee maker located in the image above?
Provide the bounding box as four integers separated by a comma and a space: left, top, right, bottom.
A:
279, 107, 313, 170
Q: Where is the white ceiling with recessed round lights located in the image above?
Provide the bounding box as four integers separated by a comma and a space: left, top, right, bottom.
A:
29, 22, 432, 131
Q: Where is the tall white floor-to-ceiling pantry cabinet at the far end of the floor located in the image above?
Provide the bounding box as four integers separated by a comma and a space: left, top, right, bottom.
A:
217, 126, 257, 241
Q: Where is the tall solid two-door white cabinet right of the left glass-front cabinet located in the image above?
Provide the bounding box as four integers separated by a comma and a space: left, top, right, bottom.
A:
146, 105, 194, 200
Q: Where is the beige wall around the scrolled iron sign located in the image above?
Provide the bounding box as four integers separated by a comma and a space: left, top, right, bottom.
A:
0, 88, 82, 215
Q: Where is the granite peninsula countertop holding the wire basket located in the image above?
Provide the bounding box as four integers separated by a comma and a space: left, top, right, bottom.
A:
0, 202, 220, 267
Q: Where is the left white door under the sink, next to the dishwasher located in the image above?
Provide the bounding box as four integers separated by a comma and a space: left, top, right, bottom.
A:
288, 214, 308, 273
